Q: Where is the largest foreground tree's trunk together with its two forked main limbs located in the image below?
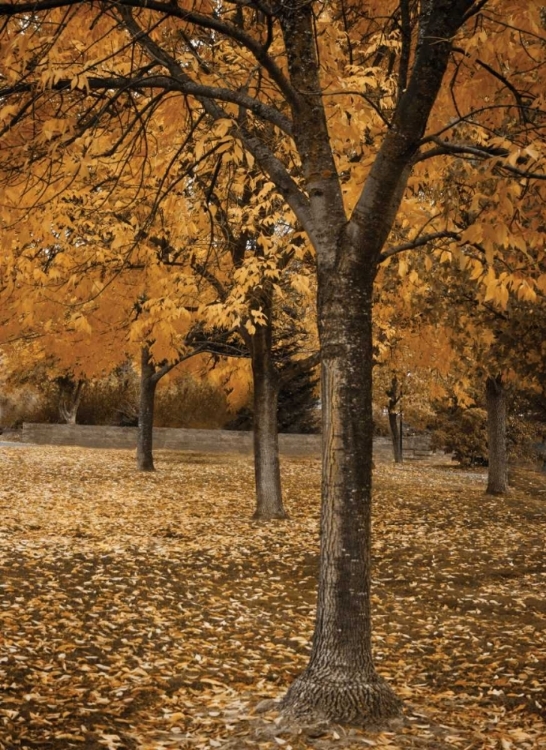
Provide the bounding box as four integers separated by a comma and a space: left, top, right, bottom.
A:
281, 0, 471, 725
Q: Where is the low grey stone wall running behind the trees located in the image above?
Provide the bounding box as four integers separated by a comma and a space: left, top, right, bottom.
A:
22, 422, 431, 461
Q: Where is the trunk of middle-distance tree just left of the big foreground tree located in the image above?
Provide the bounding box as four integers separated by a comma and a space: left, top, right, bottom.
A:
250, 310, 287, 521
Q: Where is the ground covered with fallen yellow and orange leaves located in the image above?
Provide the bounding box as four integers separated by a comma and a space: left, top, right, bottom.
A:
0, 447, 546, 750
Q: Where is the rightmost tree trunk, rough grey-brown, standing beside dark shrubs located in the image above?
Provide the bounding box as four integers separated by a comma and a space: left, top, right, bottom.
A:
485, 377, 508, 495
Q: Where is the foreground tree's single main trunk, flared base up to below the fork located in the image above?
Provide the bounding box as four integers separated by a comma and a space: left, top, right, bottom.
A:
283, 267, 401, 725
